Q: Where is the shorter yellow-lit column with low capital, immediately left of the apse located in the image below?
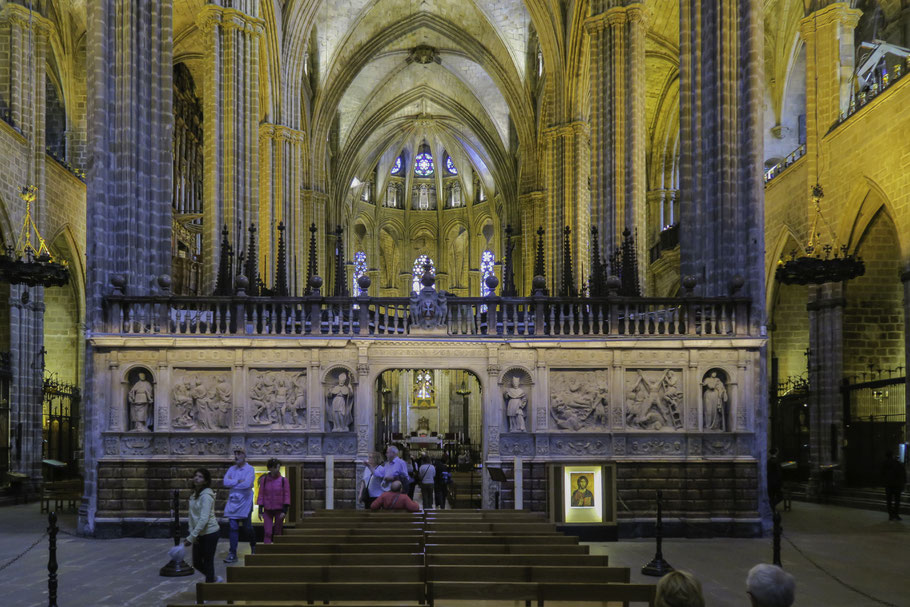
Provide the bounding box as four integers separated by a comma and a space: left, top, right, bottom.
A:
257, 124, 310, 295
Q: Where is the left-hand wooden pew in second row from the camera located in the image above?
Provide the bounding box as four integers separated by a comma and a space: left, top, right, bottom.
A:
226, 559, 426, 584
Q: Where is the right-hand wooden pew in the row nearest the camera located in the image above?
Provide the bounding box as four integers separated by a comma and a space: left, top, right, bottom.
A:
427, 582, 656, 607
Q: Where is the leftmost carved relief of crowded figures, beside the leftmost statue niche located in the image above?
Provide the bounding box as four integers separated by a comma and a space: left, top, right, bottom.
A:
171, 369, 233, 430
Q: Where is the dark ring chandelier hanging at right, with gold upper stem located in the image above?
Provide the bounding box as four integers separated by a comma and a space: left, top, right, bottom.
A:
775, 183, 866, 285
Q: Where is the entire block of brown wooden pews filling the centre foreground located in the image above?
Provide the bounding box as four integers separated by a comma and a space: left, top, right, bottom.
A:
172, 511, 654, 607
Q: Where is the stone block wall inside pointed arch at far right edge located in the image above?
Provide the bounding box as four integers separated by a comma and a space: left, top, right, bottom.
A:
844, 210, 904, 377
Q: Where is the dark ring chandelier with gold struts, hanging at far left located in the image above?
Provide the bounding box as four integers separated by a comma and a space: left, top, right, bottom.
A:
0, 185, 69, 287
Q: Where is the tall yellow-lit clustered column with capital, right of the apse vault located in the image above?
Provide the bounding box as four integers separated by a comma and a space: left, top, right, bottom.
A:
585, 0, 647, 282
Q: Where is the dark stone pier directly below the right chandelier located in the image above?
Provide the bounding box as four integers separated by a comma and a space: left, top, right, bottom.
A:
806, 282, 847, 495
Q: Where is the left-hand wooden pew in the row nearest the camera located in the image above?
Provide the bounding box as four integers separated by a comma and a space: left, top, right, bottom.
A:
196, 582, 426, 605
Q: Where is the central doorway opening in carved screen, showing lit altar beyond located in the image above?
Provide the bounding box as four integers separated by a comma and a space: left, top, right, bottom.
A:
375, 368, 483, 508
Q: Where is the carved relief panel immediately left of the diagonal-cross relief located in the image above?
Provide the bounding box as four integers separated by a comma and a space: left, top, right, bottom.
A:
550, 371, 607, 432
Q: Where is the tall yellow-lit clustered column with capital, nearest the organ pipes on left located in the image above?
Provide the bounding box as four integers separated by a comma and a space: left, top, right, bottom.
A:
196, 0, 265, 293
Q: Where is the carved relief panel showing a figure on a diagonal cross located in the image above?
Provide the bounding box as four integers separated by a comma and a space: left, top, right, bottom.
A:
625, 369, 684, 432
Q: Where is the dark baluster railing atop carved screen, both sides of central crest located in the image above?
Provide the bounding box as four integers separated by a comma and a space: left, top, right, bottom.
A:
100, 295, 750, 338
